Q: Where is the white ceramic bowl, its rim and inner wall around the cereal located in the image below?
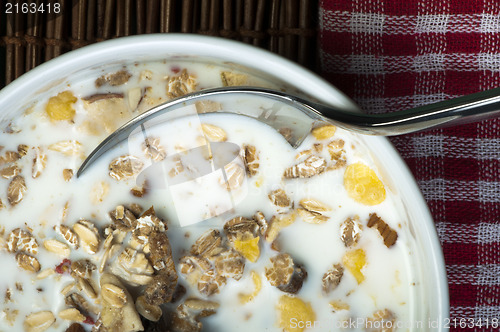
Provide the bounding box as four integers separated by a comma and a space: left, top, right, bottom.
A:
0, 34, 449, 331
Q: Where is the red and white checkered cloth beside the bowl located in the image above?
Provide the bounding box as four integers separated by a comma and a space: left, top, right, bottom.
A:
320, 0, 500, 331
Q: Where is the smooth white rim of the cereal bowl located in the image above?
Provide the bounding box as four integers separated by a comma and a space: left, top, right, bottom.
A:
0, 33, 449, 330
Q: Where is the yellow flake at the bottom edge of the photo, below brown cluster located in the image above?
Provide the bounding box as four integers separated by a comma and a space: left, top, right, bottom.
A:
277, 295, 316, 332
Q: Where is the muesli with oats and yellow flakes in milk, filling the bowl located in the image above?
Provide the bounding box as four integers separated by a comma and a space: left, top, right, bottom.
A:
0, 62, 415, 332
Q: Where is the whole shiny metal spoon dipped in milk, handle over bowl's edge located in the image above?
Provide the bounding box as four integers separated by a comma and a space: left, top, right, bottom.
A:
77, 87, 500, 177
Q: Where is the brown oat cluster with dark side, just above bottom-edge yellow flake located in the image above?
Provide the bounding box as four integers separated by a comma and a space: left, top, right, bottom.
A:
266, 253, 307, 294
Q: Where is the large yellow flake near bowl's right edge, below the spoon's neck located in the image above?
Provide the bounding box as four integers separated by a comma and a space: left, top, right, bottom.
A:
344, 163, 385, 205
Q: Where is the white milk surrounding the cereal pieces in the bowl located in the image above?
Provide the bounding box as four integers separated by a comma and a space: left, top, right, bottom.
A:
0, 62, 418, 331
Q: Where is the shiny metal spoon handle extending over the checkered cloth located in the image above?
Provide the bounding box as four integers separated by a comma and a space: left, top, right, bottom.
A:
315, 88, 500, 136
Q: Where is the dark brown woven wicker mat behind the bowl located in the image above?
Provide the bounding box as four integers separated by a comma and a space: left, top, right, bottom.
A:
0, 0, 318, 87
